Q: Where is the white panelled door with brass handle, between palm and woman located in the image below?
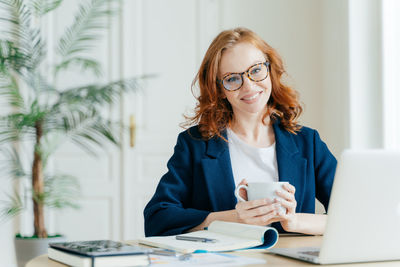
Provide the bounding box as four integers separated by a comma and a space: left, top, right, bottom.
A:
122, 0, 219, 239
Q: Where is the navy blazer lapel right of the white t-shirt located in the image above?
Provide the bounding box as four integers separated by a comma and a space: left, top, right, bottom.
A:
273, 122, 307, 210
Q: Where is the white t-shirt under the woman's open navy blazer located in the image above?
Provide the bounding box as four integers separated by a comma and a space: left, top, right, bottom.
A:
227, 128, 279, 186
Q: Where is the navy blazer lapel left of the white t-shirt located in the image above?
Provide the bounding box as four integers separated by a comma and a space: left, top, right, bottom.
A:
201, 131, 236, 211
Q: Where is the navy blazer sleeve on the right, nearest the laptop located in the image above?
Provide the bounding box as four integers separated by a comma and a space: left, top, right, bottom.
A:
314, 131, 337, 214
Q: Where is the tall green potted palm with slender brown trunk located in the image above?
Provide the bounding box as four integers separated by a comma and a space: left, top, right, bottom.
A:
0, 0, 137, 265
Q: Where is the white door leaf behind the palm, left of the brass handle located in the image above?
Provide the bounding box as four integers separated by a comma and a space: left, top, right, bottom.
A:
45, 0, 122, 240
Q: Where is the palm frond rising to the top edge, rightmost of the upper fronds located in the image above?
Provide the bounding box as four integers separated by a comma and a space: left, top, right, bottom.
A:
56, 0, 114, 74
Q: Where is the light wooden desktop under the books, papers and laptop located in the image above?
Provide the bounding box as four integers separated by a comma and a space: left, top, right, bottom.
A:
26, 236, 400, 267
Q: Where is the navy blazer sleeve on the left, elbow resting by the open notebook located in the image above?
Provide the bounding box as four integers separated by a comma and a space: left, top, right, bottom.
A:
144, 132, 210, 236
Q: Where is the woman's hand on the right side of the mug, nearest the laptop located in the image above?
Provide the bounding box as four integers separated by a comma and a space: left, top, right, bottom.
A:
274, 183, 297, 232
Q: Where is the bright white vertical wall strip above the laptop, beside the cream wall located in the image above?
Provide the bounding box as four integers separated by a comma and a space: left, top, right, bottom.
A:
348, 0, 383, 148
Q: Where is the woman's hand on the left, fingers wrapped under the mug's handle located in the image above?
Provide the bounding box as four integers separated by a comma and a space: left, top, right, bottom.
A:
235, 179, 280, 225
